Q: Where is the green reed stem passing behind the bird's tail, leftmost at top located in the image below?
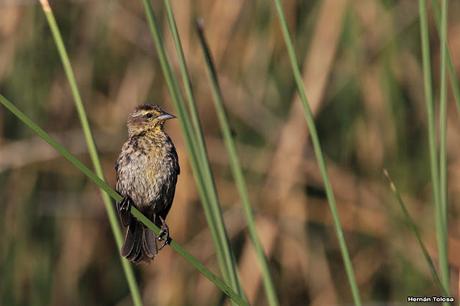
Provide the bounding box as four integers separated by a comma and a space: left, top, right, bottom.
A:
40, 0, 142, 306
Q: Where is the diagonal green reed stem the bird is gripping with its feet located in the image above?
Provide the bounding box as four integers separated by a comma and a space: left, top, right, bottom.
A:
0, 95, 248, 306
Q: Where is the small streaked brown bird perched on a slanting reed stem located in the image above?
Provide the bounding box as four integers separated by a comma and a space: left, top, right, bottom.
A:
115, 104, 180, 264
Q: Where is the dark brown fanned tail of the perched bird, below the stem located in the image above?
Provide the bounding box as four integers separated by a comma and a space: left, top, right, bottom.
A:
121, 218, 158, 263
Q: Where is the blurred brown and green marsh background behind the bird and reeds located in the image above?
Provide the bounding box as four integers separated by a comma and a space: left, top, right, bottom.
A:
0, 0, 460, 306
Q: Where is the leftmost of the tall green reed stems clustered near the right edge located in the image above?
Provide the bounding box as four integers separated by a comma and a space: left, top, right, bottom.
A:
419, 0, 449, 300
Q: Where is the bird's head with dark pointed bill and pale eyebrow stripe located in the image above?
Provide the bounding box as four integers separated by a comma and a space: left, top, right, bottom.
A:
127, 104, 176, 136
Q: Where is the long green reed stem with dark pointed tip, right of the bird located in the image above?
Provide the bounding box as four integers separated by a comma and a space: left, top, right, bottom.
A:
197, 22, 279, 306
